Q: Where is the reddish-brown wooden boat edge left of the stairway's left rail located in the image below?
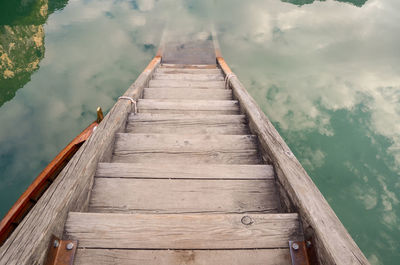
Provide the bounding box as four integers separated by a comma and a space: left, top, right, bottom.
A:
0, 121, 98, 245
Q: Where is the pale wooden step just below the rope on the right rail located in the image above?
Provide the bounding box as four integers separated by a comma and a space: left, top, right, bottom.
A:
143, 87, 232, 100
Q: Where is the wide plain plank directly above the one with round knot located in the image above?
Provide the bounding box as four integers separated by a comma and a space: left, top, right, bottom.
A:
89, 178, 278, 213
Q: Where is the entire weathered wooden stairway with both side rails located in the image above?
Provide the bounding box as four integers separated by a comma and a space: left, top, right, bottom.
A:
0, 35, 369, 265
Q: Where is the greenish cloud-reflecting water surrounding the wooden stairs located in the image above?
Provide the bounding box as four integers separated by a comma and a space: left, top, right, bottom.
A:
0, 0, 400, 265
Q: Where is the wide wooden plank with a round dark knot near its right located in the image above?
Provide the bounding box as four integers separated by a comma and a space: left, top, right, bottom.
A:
65, 212, 302, 249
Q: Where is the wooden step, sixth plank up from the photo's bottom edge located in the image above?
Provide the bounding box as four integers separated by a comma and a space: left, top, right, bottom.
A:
126, 113, 250, 135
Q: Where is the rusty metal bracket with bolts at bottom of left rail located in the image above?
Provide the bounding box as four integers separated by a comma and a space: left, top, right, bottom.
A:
45, 235, 78, 265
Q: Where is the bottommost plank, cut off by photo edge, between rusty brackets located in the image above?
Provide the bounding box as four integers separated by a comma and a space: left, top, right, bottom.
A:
74, 248, 291, 265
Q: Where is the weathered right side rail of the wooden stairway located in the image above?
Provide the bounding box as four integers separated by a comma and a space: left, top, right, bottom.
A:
218, 58, 369, 265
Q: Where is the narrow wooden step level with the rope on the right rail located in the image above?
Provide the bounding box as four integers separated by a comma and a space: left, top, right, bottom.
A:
149, 80, 225, 89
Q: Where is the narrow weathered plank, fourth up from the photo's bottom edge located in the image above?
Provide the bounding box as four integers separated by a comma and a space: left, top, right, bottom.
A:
96, 163, 274, 180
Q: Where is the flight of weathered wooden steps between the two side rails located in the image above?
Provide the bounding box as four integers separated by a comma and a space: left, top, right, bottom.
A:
64, 64, 304, 265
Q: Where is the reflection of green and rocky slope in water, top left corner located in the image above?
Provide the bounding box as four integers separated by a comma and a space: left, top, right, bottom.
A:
0, 0, 68, 107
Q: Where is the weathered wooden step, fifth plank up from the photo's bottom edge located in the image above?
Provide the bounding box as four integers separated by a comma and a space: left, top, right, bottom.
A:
112, 133, 262, 164
